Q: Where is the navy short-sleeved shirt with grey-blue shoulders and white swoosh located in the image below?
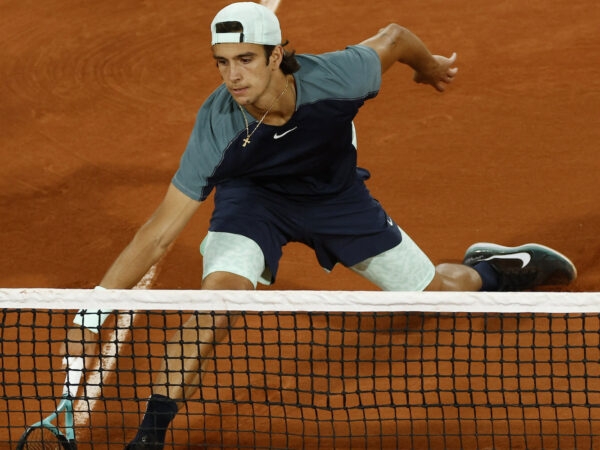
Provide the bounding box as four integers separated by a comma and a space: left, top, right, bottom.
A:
172, 45, 381, 201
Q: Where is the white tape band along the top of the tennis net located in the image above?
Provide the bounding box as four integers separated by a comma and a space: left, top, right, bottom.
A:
0, 289, 600, 313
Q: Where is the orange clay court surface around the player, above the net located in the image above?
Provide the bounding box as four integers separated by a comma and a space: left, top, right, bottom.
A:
0, 0, 600, 448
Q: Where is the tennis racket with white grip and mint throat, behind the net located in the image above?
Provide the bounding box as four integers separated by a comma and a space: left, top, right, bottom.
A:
16, 357, 83, 450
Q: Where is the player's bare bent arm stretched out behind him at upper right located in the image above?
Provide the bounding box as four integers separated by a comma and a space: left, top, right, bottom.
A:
361, 24, 458, 92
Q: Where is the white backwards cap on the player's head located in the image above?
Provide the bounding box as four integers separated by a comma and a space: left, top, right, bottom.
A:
210, 2, 281, 45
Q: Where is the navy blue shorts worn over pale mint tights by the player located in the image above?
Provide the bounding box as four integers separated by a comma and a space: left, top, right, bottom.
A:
210, 178, 402, 282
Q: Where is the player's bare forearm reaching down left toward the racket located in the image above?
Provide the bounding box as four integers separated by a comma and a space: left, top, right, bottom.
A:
63, 184, 200, 356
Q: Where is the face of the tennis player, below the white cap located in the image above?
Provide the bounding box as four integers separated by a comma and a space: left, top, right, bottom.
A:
213, 43, 279, 106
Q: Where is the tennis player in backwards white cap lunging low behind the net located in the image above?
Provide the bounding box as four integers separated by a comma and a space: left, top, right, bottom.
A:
63, 2, 576, 450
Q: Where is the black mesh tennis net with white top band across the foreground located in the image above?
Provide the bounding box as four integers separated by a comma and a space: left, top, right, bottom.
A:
0, 290, 600, 449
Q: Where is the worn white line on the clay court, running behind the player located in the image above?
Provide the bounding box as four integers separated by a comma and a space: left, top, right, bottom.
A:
73, 0, 281, 426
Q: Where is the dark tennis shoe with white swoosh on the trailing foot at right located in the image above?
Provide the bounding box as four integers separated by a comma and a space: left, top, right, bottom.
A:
463, 242, 577, 291
